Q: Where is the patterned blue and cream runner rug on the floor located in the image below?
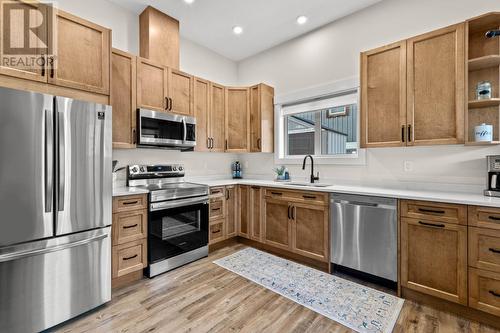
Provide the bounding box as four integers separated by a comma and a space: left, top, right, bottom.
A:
214, 248, 404, 333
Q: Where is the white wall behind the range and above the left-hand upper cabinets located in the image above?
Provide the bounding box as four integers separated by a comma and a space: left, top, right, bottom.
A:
57, 0, 238, 179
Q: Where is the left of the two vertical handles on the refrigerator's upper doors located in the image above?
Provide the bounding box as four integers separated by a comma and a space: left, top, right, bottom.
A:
44, 110, 54, 213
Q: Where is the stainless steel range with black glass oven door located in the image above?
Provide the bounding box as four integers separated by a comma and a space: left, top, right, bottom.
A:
127, 164, 208, 278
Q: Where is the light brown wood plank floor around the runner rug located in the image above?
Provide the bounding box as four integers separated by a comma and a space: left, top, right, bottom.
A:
56, 244, 500, 333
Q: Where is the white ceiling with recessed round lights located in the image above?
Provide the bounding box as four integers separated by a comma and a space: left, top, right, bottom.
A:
111, 0, 381, 61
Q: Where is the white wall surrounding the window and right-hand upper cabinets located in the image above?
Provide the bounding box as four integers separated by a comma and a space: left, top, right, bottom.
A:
238, 0, 500, 191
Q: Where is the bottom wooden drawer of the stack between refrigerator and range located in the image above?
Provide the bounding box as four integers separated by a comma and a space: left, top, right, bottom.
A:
112, 239, 147, 278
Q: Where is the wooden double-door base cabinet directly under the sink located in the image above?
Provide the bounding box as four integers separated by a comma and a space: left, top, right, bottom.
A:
263, 189, 330, 262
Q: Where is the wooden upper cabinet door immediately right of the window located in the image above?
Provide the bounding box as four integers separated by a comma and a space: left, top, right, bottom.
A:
361, 41, 406, 148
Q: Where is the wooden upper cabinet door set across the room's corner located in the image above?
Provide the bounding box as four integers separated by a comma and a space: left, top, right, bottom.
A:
225, 88, 250, 153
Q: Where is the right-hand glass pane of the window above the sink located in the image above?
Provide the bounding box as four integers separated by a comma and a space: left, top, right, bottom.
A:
318, 104, 358, 155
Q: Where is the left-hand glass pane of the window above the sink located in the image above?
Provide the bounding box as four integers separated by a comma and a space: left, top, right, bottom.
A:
286, 112, 316, 155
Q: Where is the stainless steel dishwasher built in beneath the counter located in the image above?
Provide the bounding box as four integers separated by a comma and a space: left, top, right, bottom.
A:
330, 193, 398, 282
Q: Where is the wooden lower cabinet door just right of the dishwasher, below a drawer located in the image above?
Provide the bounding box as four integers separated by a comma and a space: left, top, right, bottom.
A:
401, 217, 467, 305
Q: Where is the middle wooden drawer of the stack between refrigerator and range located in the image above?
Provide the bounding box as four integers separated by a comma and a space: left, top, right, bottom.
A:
113, 209, 148, 245
